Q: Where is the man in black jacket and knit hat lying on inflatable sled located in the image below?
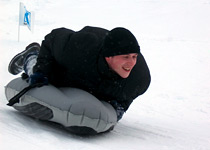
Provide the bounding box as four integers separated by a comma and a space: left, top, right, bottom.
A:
8, 26, 150, 135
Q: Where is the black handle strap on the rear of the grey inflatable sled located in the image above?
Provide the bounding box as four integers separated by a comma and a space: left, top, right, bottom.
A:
7, 83, 45, 106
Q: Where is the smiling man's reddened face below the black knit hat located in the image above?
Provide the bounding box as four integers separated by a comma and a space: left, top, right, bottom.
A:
105, 53, 138, 78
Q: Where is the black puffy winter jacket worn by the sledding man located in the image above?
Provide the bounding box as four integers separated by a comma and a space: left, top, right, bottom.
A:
34, 26, 150, 110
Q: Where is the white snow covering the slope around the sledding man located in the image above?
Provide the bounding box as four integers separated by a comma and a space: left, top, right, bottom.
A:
0, 0, 210, 150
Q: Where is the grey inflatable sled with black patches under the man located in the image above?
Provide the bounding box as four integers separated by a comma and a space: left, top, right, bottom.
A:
5, 78, 117, 135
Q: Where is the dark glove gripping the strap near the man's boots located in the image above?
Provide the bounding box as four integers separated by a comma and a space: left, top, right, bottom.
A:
29, 72, 48, 85
